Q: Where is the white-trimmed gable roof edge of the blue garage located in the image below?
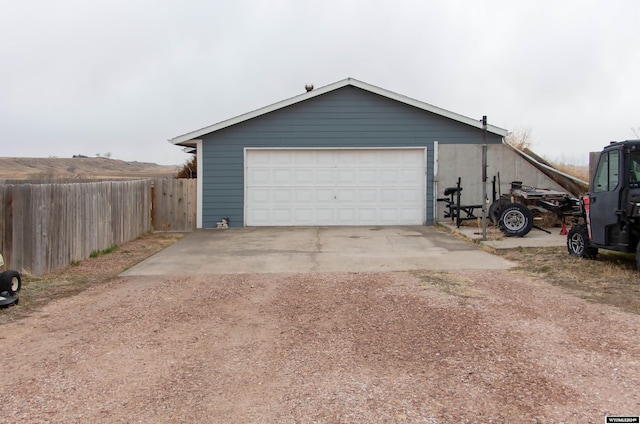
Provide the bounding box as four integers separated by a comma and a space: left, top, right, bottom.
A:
169, 78, 508, 146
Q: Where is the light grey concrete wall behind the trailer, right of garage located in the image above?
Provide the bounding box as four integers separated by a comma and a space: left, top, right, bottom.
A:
436, 144, 566, 221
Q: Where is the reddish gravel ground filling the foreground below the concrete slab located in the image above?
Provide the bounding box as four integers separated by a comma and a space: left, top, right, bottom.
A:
0, 235, 640, 423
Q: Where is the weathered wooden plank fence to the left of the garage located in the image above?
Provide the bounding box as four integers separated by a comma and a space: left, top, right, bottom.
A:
0, 179, 195, 276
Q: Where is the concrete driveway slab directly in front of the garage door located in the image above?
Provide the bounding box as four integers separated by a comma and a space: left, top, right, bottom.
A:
121, 226, 513, 276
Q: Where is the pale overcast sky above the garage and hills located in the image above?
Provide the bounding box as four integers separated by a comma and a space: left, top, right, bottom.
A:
0, 0, 640, 164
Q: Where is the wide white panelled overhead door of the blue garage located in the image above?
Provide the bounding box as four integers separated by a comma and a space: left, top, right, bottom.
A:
245, 148, 426, 226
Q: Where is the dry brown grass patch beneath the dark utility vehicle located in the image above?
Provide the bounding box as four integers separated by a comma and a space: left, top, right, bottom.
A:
497, 247, 640, 314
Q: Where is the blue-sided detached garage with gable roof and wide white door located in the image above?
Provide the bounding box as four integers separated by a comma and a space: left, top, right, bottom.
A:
170, 78, 507, 228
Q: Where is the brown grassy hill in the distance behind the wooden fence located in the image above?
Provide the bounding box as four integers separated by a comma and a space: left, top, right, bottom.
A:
0, 157, 180, 180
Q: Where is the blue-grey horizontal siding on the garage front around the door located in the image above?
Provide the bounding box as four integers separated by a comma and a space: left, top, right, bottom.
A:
201, 86, 502, 228
